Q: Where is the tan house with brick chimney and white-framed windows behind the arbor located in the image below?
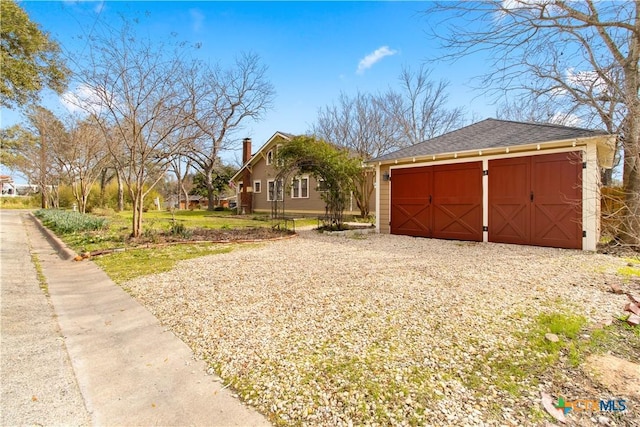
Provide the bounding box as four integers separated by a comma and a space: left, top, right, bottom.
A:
231, 132, 373, 216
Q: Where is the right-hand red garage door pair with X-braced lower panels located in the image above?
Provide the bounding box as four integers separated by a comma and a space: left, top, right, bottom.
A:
489, 151, 582, 249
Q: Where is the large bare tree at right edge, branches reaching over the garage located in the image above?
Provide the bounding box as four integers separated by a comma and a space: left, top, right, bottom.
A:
426, 0, 640, 246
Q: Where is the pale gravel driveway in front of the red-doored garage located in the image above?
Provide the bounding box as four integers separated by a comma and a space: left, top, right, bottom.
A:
123, 231, 638, 425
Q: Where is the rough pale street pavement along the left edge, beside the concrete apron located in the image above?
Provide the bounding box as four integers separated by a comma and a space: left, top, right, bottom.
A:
0, 210, 91, 426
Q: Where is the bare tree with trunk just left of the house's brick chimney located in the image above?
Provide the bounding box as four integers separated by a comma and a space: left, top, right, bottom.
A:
182, 54, 275, 210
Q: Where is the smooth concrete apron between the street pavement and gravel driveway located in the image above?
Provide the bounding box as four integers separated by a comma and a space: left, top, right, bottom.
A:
3, 214, 269, 426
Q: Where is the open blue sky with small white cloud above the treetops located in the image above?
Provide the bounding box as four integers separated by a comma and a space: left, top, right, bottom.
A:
2, 1, 495, 172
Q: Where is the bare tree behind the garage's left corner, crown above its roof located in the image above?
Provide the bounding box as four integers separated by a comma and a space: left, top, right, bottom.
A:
312, 67, 464, 216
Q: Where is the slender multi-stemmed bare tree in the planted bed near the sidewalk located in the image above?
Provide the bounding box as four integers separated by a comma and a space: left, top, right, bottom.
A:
71, 22, 194, 237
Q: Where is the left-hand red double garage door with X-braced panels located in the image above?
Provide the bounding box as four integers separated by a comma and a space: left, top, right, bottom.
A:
391, 162, 482, 241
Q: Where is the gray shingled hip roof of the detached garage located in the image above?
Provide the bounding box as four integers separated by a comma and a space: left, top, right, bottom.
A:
370, 119, 607, 162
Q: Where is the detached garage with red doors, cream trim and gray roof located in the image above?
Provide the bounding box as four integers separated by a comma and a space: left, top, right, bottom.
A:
369, 119, 616, 250
